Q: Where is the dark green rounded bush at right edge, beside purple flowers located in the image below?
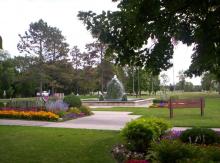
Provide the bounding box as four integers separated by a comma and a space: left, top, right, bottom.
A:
180, 128, 219, 145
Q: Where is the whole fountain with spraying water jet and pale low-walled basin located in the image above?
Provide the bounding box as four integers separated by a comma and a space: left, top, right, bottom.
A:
82, 75, 153, 107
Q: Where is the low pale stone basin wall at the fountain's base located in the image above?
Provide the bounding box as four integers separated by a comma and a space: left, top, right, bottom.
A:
82, 98, 154, 107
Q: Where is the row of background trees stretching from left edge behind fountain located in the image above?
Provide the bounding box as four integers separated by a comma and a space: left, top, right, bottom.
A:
0, 20, 160, 97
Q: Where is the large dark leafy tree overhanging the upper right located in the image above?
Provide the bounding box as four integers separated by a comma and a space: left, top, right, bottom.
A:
78, 0, 220, 81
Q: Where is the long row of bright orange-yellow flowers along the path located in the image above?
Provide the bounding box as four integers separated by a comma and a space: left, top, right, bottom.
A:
0, 110, 59, 121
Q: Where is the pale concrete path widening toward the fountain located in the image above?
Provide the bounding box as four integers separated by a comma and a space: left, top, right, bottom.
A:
0, 111, 140, 130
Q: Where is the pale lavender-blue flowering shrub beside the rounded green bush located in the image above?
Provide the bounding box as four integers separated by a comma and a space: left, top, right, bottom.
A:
45, 100, 68, 113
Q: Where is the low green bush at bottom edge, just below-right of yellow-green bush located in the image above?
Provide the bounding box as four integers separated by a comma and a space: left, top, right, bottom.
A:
147, 140, 201, 163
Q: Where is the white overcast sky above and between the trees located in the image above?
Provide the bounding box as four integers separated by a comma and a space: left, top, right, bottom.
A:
0, 0, 200, 85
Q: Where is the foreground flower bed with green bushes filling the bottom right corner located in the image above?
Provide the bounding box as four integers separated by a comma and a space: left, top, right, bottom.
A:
112, 118, 220, 163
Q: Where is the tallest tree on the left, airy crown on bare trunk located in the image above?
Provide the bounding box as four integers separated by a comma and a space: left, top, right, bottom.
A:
17, 19, 69, 92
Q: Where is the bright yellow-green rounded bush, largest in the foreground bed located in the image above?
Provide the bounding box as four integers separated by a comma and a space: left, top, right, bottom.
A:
122, 118, 169, 152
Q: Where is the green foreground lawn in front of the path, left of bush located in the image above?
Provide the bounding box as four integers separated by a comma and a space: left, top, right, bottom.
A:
0, 126, 121, 163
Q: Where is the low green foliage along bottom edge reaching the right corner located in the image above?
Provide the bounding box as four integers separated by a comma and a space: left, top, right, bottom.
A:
147, 140, 220, 163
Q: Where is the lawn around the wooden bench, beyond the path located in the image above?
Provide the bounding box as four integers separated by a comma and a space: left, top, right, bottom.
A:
93, 97, 220, 128
